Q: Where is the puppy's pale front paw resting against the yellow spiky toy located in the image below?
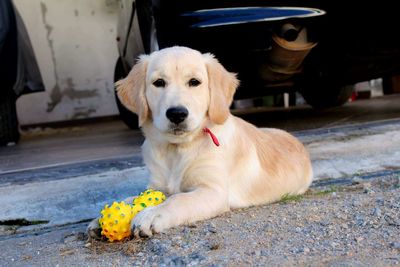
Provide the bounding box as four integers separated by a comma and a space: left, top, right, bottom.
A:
131, 206, 172, 237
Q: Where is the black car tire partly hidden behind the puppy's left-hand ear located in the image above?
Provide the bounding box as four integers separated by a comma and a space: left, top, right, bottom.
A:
114, 58, 139, 129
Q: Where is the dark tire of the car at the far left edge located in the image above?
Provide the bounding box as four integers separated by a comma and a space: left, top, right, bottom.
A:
0, 93, 20, 146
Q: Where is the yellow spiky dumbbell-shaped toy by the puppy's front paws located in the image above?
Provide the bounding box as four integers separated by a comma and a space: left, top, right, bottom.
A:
99, 189, 165, 242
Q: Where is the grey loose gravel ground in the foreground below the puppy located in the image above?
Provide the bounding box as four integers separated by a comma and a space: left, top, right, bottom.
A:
0, 174, 400, 266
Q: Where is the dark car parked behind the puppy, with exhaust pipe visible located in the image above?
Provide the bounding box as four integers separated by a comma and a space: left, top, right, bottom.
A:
115, 0, 400, 127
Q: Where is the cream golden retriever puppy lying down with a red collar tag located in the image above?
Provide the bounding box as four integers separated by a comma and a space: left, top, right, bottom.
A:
89, 47, 312, 239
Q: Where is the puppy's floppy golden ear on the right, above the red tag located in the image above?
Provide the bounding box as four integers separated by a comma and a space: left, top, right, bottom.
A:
203, 54, 239, 124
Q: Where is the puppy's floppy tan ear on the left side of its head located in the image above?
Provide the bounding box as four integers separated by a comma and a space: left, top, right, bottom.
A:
115, 56, 149, 126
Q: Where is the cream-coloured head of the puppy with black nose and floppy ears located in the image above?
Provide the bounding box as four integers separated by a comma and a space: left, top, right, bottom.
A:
116, 47, 239, 142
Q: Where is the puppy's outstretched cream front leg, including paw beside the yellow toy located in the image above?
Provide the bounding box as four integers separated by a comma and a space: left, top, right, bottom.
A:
131, 187, 229, 237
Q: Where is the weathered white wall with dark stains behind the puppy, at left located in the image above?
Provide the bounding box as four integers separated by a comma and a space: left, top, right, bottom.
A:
14, 0, 119, 125
